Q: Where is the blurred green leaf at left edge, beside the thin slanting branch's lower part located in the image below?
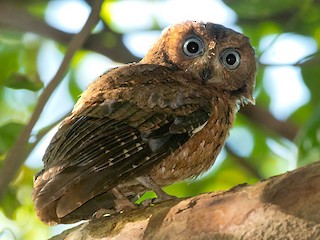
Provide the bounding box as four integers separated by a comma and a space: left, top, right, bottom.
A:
0, 122, 24, 154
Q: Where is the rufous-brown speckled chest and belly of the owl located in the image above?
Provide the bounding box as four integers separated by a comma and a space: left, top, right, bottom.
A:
149, 99, 235, 186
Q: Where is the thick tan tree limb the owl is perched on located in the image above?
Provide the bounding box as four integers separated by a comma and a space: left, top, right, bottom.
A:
52, 162, 320, 240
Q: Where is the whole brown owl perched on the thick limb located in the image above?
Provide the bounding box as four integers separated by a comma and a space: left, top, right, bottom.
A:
33, 21, 256, 225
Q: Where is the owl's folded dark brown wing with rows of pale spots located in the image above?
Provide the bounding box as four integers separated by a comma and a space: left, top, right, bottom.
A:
33, 65, 210, 217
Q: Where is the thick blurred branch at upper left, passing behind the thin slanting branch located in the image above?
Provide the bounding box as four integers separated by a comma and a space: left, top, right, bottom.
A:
0, 1, 140, 63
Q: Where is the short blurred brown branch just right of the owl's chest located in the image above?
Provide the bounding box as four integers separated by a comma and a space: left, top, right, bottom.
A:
240, 105, 298, 141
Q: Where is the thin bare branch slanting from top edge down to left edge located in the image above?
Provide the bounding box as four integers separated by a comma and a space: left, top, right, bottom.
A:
0, 0, 102, 199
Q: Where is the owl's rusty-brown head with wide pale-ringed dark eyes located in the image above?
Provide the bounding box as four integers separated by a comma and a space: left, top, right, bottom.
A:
141, 21, 257, 103
